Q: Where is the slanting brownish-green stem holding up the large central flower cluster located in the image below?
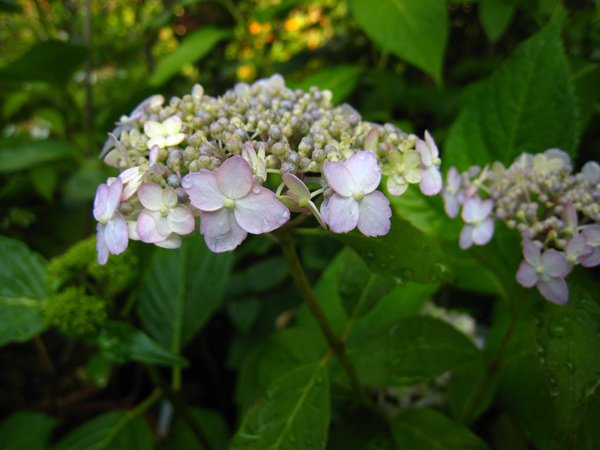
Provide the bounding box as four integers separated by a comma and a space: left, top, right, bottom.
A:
279, 229, 388, 421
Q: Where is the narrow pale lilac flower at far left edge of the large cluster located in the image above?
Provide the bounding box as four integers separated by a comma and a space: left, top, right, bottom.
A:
94, 178, 129, 265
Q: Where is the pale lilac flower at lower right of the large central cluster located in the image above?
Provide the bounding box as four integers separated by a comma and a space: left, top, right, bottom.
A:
321, 151, 392, 236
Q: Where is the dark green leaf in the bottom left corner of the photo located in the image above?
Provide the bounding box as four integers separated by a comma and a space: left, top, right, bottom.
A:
0, 411, 59, 450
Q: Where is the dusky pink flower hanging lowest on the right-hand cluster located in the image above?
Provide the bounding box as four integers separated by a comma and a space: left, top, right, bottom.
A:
517, 239, 569, 305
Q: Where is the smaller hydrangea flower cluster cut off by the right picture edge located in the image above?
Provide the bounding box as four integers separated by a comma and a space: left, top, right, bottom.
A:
442, 149, 600, 305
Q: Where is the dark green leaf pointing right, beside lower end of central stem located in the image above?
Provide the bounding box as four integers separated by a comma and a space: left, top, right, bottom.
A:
348, 316, 481, 386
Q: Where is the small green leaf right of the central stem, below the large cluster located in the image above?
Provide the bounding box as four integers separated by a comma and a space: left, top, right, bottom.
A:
338, 248, 397, 320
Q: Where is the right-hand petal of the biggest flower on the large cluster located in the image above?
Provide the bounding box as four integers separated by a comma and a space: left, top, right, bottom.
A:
233, 185, 290, 234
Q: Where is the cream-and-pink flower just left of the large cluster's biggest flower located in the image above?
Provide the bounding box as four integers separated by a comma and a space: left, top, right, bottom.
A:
136, 183, 196, 244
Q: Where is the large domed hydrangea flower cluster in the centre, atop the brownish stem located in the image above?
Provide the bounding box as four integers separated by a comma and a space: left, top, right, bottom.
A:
94, 75, 442, 264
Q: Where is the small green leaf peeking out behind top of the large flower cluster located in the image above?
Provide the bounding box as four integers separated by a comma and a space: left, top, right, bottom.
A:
288, 64, 362, 105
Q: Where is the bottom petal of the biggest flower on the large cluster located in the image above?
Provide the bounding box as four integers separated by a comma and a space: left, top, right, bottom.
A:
200, 208, 248, 253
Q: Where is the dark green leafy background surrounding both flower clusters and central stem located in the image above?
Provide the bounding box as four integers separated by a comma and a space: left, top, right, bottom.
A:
0, 0, 600, 450
